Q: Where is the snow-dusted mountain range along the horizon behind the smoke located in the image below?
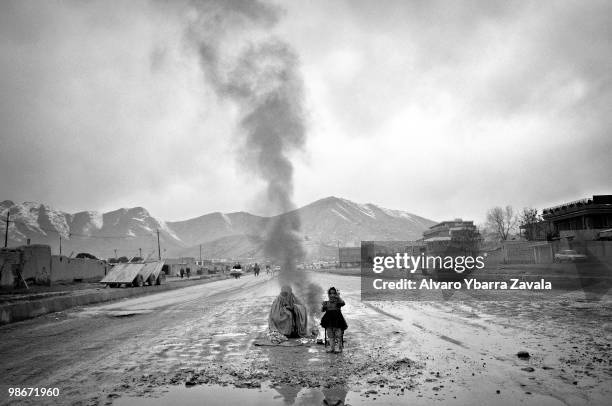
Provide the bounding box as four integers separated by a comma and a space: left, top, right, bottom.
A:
0, 197, 435, 260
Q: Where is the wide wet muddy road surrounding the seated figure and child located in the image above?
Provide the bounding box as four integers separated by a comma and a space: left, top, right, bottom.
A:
0, 273, 612, 405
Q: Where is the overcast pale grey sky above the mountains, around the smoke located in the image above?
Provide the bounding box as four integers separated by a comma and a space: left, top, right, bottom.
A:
0, 0, 612, 222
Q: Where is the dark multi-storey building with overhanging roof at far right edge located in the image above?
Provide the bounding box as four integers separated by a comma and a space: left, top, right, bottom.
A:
542, 195, 612, 240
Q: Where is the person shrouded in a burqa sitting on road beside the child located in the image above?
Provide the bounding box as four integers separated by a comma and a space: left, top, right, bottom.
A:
268, 285, 308, 338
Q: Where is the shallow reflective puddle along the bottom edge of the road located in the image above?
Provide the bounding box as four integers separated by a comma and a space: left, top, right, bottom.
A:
113, 385, 563, 406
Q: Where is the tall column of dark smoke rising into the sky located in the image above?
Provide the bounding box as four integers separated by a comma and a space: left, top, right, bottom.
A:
184, 1, 323, 322
